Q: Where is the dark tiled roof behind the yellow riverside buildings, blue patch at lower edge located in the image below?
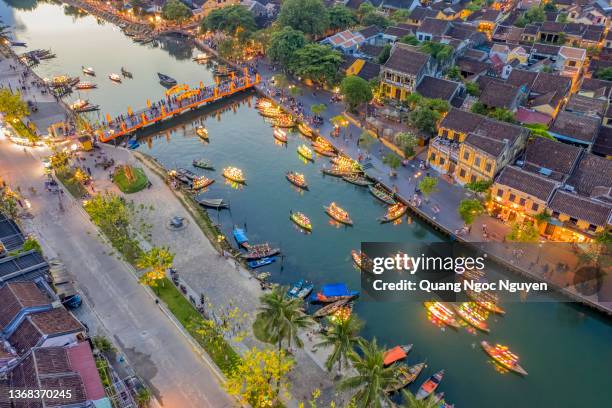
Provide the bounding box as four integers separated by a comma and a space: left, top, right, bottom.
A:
524, 137, 582, 180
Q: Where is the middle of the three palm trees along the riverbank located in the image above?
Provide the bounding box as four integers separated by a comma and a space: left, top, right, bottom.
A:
316, 315, 363, 372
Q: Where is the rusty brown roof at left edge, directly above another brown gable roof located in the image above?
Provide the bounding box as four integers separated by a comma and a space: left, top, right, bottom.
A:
0, 282, 51, 330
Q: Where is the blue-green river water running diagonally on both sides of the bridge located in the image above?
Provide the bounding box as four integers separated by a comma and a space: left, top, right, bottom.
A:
0, 0, 612, 408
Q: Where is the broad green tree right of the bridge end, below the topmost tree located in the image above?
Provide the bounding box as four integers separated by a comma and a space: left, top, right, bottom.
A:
288, 43, 342, 85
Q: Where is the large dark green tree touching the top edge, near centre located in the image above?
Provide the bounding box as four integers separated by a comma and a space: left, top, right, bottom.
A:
277, 0, 329, 37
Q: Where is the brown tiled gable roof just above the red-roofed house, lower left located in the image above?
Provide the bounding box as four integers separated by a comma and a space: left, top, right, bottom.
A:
8, 307, 84, 355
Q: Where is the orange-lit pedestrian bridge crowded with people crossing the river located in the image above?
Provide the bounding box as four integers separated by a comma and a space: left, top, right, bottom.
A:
93, 68, 260, 142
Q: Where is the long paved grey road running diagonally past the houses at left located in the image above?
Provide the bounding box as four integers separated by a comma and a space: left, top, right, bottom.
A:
0, 139, 236, 408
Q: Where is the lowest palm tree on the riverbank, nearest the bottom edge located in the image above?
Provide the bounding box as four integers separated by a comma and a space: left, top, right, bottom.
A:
339, 339, 399, 408
